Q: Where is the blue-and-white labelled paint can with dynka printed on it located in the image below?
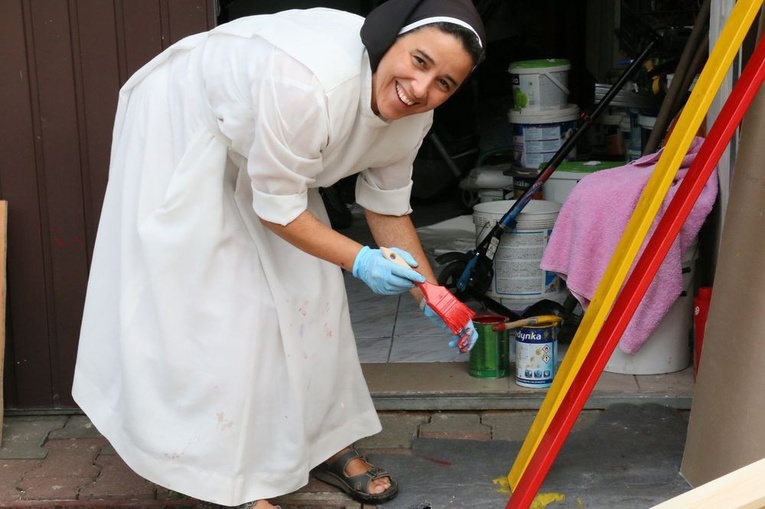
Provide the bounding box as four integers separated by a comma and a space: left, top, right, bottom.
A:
515, 324, 558, 388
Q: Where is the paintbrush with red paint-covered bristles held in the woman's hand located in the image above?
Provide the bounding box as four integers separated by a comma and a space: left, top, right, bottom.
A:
380, 247, 475, 352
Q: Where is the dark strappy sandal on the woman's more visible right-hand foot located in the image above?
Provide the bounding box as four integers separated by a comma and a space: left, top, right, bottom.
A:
311, 448, 398, 504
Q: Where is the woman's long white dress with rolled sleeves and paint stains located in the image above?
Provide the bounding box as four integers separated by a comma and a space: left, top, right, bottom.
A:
73, 9, 432, 505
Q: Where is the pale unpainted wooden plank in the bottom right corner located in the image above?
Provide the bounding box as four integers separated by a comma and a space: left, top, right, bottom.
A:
652, 459, 765, 509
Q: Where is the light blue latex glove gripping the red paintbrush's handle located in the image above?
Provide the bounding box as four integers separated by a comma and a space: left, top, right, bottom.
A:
352, 246, 425, 295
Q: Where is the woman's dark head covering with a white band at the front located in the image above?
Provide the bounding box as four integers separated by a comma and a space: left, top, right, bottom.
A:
361, 0, 486, 71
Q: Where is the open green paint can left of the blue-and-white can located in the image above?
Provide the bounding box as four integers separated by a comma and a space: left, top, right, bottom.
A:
468, 315, 511, 378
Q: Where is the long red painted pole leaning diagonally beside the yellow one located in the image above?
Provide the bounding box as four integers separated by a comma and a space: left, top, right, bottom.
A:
505, 38, 765, 509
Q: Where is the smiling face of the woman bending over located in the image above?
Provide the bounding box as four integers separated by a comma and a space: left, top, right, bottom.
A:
372, 27, 473, 120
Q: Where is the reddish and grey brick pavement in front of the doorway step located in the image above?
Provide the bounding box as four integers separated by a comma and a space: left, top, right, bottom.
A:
0, 411, 548, 509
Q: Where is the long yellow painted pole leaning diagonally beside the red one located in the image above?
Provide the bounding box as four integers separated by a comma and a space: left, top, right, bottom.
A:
507, 0, 763, 489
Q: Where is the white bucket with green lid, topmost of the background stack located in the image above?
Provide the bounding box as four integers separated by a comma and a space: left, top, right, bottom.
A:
507, 58, 571, 113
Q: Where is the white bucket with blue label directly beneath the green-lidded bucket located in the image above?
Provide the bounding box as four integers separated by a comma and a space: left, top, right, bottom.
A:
508, 104, 579, 168
